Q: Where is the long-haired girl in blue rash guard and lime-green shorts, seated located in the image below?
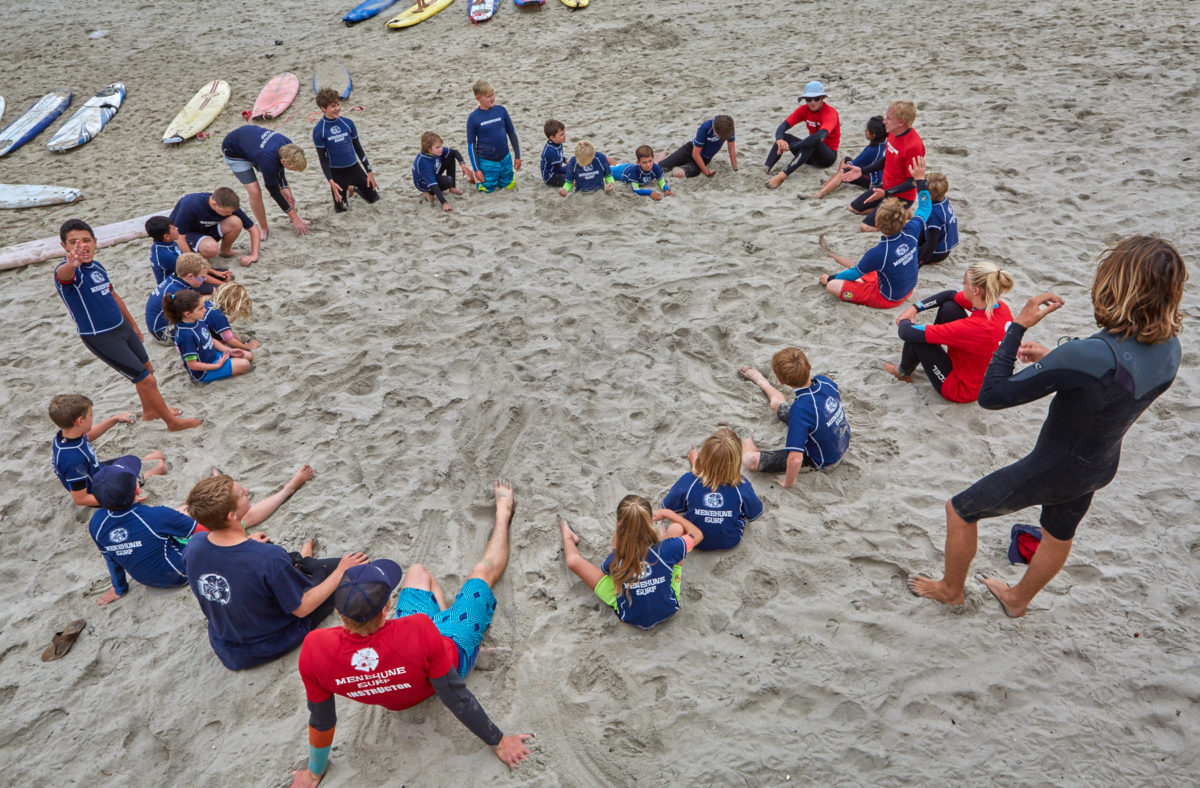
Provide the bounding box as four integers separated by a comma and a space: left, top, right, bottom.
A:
558, 495, 704, 630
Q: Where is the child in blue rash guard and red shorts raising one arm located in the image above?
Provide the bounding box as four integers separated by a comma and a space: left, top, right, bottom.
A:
821, 157, 930, 309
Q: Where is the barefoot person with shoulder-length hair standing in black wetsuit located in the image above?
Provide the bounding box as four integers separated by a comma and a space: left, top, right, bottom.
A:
908, 235, 1187, 618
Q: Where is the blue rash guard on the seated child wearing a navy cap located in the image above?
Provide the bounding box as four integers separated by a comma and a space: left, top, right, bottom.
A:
88, 504, 196, 597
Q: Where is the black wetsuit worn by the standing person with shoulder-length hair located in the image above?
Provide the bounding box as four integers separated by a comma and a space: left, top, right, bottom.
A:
950, 323, 1181, 540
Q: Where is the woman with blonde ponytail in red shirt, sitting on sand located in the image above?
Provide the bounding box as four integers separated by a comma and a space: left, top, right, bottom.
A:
883, 260, 1013, 402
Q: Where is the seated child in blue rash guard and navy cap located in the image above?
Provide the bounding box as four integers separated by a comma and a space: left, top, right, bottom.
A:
88, 456, 206, 606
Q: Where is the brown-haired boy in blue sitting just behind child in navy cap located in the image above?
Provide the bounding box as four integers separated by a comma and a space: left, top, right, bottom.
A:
48, 395, 167, 506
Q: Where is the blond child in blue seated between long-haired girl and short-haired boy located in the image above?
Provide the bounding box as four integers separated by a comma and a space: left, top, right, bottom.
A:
662, 427, 762, 551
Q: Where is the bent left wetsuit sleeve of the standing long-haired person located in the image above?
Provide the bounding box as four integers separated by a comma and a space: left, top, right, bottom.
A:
979, 323, 1115, 410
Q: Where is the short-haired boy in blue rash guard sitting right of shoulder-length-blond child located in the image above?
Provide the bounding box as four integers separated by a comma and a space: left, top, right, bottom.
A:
738, 348, 850, 488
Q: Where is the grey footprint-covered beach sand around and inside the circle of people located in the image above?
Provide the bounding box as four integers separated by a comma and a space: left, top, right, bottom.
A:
0, 0, 1200, 787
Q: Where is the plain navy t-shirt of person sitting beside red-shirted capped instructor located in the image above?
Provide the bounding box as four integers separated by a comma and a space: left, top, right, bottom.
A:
184, 534, 312, 670
